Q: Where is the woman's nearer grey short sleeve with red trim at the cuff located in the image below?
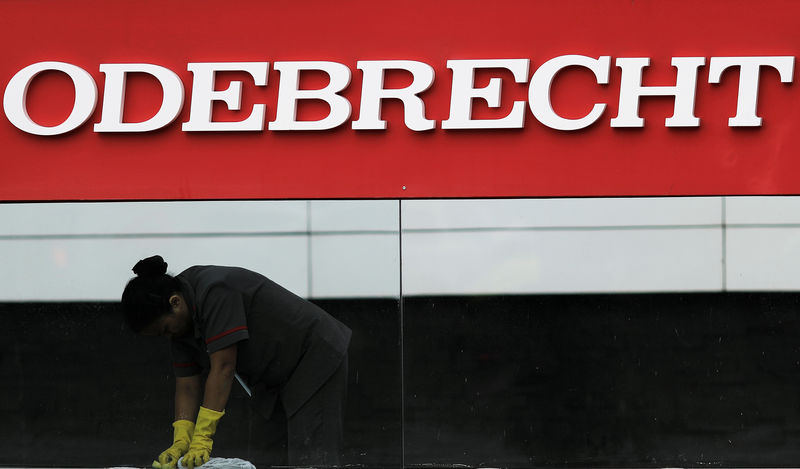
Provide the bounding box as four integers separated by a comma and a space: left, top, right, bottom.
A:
202, 286, 250, 354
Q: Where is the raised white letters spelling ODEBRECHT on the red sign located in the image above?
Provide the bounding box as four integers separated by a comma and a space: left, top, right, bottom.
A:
3, 55, 794, 136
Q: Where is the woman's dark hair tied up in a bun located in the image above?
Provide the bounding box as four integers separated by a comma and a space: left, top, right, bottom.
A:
122, 255, 181, 334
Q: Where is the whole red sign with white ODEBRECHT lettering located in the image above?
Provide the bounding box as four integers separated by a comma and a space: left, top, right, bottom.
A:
0, 0, 800, 201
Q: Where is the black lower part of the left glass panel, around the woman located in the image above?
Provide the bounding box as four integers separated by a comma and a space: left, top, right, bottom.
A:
0, 299, 401, 467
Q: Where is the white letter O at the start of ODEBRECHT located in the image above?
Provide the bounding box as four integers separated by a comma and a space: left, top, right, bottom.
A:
3, 62, 97, 135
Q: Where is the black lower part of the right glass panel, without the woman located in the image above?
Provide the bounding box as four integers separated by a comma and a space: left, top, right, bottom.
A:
403, 293, 800, 467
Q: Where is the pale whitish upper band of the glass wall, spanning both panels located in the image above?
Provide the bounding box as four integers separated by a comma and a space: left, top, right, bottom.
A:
0, 197, 800, 301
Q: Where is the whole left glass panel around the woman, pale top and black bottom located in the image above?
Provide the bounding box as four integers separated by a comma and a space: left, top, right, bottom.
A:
0, 201, 401, 467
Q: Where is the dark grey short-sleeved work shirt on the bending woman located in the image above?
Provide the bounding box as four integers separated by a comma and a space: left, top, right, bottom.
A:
171, 266, 351, 417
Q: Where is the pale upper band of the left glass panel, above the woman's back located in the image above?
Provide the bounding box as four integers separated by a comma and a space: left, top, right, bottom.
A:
0, 201, 399, 301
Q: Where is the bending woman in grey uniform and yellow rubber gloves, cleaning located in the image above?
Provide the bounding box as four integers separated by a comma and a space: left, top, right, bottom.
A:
122, 256, 351, 469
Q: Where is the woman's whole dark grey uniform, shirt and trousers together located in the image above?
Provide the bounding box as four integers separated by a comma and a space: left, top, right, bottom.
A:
171, 266, 351, 464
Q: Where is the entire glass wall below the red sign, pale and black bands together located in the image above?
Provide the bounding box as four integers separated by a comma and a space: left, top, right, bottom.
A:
0, 197, 800, 468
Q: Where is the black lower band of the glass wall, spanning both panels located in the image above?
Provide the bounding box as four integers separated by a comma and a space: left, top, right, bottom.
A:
0, 293, 800, 468
